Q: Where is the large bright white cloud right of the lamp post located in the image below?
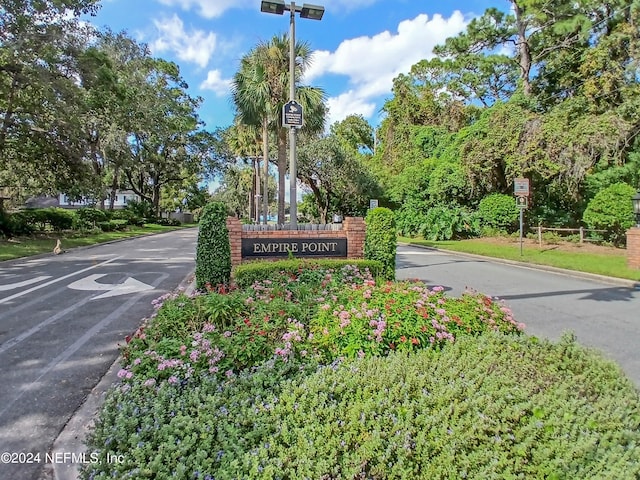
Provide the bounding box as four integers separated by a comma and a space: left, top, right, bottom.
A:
304, 11, 467, 122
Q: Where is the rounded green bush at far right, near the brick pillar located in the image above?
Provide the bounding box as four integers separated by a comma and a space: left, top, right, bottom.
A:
582, 183, 636, 246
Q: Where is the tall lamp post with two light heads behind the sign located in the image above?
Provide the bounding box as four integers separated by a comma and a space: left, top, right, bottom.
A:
260, 0, 324, 228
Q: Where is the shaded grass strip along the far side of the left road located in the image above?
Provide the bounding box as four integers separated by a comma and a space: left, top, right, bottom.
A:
0, 224, 195, 262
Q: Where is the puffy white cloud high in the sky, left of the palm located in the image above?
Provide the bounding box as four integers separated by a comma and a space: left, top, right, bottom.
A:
149, 15, 216, 68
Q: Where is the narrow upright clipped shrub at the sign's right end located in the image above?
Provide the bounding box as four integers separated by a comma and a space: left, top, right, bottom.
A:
364, 207, 397, 280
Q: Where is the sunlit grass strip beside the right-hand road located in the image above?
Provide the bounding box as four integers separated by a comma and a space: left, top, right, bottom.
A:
398, 237, 640, 280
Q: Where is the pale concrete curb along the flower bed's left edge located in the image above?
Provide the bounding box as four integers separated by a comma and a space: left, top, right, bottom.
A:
45, 271, 195, 480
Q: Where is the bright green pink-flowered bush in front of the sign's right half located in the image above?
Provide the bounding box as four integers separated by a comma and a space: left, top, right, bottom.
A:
311, 282, 524, 359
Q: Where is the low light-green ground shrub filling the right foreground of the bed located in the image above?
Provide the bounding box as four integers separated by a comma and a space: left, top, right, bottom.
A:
236, 335, 640, 480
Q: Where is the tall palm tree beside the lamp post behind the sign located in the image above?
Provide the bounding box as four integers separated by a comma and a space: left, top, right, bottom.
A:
232, 34, 326, 223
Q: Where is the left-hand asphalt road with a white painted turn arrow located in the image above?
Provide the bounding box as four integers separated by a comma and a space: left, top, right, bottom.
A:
0, 229, 197, 479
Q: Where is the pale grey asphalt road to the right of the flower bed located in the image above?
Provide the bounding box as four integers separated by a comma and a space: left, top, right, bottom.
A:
396, 247, 640, 387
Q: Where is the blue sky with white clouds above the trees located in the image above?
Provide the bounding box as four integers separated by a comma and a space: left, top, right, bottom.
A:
90, 0, 500, 130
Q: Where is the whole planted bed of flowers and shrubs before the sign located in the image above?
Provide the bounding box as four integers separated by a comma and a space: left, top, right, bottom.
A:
82, 262, 640, 479
